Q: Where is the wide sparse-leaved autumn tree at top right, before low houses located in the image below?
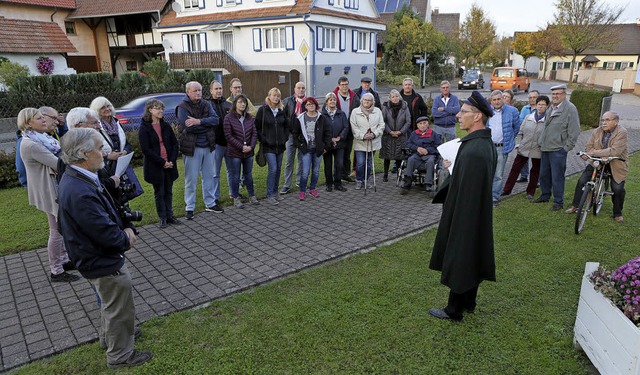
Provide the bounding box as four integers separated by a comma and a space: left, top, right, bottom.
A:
555, 0, 624, 80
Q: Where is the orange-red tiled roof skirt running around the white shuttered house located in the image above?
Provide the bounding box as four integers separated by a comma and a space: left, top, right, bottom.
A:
160, 0, 383, 27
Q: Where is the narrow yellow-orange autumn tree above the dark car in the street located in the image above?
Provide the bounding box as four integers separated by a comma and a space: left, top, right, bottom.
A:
460, 3, 496, 67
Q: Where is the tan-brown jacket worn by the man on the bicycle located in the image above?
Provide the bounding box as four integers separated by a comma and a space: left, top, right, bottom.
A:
585, 124, 629, 183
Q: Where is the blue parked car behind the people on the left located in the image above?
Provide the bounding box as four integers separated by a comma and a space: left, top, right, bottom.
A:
116, 92, 185, 131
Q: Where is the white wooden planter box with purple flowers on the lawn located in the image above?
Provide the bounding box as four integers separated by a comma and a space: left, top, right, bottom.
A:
574, 257, 640, 375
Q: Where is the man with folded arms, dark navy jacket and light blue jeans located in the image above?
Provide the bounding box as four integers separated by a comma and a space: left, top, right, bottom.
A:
176, 81, 218, 220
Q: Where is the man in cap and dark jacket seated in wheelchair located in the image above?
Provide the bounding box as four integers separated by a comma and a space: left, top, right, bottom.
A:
401, 116, 442, 195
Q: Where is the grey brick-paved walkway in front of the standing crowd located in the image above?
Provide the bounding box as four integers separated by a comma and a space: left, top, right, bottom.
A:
0, 98, 640, 371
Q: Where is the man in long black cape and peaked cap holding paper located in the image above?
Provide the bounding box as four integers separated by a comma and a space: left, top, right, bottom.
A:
429, 91, 498, 321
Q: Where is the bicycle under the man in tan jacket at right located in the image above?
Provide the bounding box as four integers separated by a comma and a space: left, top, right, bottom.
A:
575, 152, 620, 234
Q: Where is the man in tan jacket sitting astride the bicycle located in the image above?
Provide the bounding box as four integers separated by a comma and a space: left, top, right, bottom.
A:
565, 112, 629, 223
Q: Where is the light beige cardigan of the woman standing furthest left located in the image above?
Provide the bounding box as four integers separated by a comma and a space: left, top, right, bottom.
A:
20, 137, 58, 217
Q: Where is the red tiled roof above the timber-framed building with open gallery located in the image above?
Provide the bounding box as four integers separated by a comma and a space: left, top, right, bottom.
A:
67, 0, 168, 19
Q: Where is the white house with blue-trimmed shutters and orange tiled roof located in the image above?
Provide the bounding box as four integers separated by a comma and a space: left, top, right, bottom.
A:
157, 0, 385, 96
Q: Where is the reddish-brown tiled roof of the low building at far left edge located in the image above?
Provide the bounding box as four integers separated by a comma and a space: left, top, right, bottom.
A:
0, 17, 78, 53
